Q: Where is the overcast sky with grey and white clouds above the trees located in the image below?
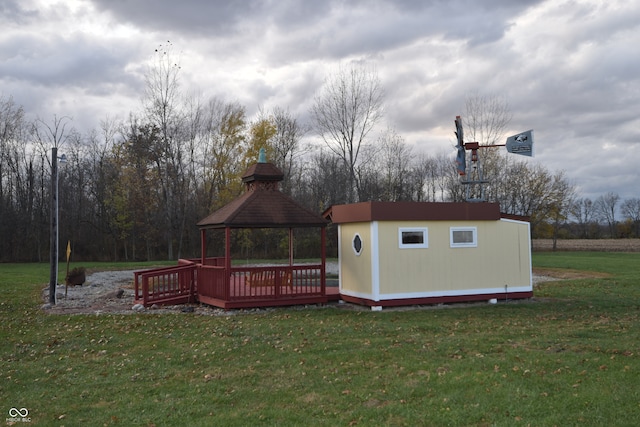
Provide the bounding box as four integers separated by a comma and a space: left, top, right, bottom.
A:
0, 0, 640, 199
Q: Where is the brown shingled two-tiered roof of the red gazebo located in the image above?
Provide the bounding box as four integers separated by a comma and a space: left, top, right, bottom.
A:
198, 159, 328, 229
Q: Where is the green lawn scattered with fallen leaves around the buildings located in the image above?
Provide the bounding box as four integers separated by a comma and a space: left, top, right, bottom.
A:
0, 252, 640, 426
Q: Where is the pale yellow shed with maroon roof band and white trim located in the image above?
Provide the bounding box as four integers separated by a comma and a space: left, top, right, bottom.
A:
326, 202, 533, 307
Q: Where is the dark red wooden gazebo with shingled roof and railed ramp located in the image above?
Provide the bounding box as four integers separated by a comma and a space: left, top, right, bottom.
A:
135, 151, 330, 309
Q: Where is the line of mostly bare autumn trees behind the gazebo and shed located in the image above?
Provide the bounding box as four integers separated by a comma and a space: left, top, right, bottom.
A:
0, 51, 640, 262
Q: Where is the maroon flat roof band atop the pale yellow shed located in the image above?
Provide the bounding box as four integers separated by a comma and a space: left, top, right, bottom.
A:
324, 202, 501, 224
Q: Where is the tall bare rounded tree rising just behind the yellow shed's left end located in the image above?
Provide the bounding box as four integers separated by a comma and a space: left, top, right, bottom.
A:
311, 64, 383, 202
